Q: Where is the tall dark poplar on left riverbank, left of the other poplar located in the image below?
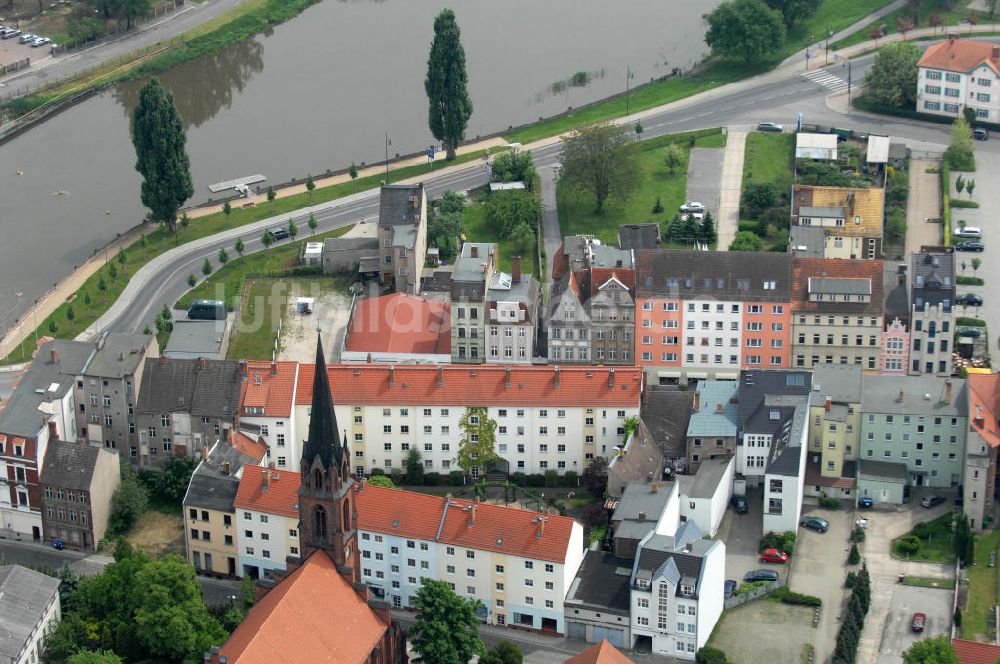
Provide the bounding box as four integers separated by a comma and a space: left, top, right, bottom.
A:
132, 78, 194, 232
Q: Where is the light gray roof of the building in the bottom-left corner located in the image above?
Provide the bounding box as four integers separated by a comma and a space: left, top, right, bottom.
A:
0, 565, 59, 661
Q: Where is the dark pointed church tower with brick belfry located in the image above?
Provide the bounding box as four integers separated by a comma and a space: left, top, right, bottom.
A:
299, 339, 361, 583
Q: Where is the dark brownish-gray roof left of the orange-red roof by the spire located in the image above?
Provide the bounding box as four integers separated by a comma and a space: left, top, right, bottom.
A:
135, 357, 243, 418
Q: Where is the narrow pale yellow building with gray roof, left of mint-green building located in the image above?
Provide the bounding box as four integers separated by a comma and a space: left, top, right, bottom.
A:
805, 364, 862, 498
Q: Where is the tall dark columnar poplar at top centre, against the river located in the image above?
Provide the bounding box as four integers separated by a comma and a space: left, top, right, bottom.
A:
424, 9, 472, 160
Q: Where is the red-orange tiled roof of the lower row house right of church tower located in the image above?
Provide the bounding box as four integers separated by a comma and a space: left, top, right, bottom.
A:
355, 484, 575, 563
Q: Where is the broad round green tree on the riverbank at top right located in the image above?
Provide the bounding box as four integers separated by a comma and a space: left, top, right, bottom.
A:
704, 0, 785, 62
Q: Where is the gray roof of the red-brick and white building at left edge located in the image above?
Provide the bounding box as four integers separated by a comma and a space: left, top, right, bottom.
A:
0, 339, 94, 438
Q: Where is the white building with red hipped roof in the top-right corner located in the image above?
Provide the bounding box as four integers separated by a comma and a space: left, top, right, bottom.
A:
916, 35, 1000, 123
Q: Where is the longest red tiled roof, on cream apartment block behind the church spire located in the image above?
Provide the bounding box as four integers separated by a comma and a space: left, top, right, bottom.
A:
295, 364, 644, 408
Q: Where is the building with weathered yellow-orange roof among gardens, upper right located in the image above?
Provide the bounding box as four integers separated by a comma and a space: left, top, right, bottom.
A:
788, 184, 885, 260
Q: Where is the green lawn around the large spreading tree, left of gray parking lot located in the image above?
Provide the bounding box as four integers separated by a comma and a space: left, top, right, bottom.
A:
556, 133, 725, 248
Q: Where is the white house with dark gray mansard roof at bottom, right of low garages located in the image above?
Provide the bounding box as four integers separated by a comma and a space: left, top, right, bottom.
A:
630, 521, 726, 661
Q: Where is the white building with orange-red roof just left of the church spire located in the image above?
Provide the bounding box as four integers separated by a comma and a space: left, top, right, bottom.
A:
239, 361, 302, 472
